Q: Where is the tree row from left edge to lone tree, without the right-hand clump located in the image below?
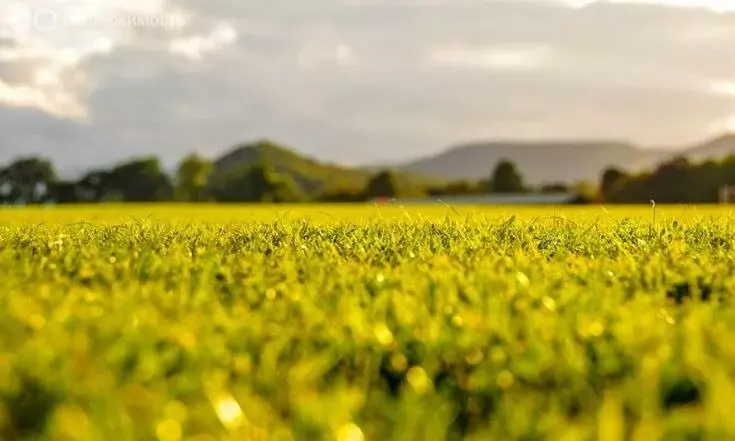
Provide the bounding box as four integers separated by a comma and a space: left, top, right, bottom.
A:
0, 150, 566, 205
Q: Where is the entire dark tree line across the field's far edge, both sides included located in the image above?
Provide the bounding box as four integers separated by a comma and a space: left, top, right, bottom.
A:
0, 146, 735, 205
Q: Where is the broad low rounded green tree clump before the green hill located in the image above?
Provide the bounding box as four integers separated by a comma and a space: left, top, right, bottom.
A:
210, 165, 306, 203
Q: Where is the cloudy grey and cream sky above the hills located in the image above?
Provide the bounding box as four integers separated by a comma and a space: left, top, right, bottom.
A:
0, 0, 735, 174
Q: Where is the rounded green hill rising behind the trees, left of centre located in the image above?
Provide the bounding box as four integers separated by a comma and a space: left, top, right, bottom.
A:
214, 141, 437, 195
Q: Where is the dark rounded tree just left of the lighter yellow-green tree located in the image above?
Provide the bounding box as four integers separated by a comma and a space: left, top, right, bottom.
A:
103, 157, 173, 202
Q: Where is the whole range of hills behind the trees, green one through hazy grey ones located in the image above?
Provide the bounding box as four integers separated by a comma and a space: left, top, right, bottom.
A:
60, 134, 735, 187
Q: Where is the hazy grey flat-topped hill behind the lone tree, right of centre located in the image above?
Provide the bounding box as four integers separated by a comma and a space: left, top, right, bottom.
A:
400, 141, 668, 184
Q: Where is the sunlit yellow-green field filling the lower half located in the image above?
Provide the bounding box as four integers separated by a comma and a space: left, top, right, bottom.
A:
0, 205, 735, 441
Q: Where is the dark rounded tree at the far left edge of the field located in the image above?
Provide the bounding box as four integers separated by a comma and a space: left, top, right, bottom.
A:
0, 157, 57, 204
